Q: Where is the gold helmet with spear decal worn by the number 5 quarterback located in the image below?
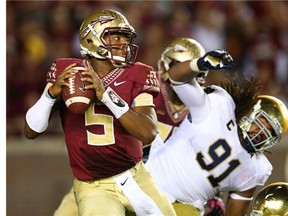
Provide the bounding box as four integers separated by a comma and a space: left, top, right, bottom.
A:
79, 10, 138, 67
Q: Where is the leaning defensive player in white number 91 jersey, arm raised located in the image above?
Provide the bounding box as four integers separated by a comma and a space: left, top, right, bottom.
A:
146, 41, 288, 216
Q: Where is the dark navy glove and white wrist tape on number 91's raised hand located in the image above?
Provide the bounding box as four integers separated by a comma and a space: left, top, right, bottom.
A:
190, 49, 234, 72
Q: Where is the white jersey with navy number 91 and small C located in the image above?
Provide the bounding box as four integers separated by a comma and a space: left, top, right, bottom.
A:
146, 78, 272, 211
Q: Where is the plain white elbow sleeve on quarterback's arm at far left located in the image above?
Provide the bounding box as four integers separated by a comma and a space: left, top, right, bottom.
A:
26, 89, 56, 133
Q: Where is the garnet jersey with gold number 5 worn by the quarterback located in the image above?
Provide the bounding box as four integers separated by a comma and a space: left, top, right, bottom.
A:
47, 58, 159, 180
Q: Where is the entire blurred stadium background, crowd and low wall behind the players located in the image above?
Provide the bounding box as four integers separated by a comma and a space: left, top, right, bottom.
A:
6, 0, 288, 216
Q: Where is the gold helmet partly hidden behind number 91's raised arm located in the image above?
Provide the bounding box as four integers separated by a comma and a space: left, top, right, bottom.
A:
158, 37, 207, 81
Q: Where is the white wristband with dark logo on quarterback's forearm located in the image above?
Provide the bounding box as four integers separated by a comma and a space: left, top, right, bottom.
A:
101, 86, 129, 119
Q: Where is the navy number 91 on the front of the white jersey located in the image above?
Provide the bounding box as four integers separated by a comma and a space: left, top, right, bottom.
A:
197, 139, 240, 187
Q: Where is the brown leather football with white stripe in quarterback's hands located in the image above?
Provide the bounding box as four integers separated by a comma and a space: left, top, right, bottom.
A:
61, 66, 95, 114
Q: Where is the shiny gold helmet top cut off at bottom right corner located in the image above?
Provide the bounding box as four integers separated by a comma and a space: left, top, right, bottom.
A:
250, 182, 288, 216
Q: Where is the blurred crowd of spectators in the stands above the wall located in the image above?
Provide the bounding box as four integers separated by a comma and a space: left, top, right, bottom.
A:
6, 0, 288, 137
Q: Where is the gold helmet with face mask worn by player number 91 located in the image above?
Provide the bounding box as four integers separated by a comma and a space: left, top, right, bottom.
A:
239, 95, 288, 153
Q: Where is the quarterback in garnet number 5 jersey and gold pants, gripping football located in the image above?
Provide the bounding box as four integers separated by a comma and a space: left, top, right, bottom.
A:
24, 10, 176, 216
